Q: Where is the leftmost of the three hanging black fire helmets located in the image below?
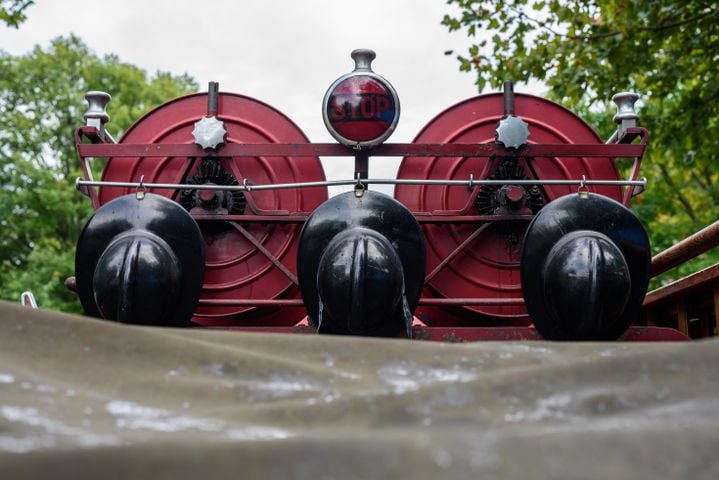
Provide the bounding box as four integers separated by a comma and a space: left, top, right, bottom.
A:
75, 193, 205, 327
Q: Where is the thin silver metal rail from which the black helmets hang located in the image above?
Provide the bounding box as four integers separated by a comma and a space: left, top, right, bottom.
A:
75, 177, 647, 192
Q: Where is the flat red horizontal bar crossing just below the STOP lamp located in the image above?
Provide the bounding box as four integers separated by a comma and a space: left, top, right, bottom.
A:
77, 143, 646, 158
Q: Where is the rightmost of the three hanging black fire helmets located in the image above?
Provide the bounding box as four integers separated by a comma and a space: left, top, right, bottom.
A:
520, 193, 651, 340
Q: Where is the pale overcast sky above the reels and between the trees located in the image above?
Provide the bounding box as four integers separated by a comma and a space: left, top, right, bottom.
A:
0, 0, 540, 193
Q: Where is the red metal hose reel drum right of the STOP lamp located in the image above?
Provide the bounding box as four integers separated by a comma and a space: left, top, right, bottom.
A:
395, 94, 622, 325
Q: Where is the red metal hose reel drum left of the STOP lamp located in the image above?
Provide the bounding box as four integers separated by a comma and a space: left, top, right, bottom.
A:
99, 93, 327, 326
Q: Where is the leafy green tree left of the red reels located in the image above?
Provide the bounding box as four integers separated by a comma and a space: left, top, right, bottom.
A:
0, 36, 197, 312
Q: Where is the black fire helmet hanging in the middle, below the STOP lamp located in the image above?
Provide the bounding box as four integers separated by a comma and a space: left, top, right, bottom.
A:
297, 191, 426, 336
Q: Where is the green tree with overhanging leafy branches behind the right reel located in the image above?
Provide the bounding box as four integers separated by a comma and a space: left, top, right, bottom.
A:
443, 0, 719, 282
